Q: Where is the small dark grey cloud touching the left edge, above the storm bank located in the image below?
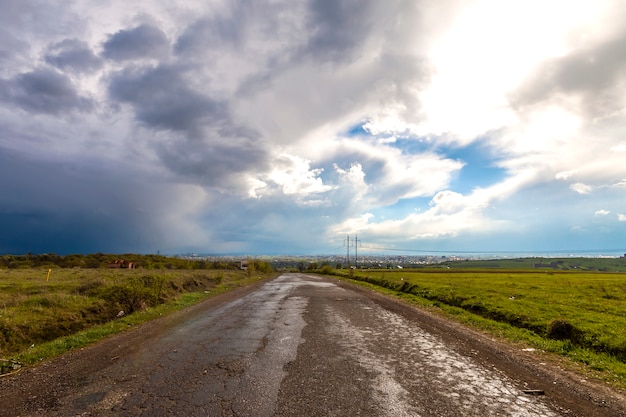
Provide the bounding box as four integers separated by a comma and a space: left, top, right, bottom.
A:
0, 68, 93, 115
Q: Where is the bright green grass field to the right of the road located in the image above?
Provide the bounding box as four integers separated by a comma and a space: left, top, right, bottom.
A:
326, 268, 626, 389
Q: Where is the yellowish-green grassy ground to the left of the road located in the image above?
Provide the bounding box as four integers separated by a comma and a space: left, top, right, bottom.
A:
0, 269, 272, 374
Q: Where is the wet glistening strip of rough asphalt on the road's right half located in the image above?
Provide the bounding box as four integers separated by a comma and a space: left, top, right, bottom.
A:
326, 305, 558, 417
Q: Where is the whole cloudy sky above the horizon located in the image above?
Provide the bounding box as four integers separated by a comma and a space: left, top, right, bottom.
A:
0, 0, 626, 255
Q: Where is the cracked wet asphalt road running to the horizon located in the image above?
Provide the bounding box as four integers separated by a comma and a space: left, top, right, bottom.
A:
0, 274, 622, 417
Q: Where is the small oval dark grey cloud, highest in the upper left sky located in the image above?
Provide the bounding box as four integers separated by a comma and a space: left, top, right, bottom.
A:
102, 24, 170, 61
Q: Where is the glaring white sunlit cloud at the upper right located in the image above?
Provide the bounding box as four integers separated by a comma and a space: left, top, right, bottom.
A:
364, 0, 608, 143
